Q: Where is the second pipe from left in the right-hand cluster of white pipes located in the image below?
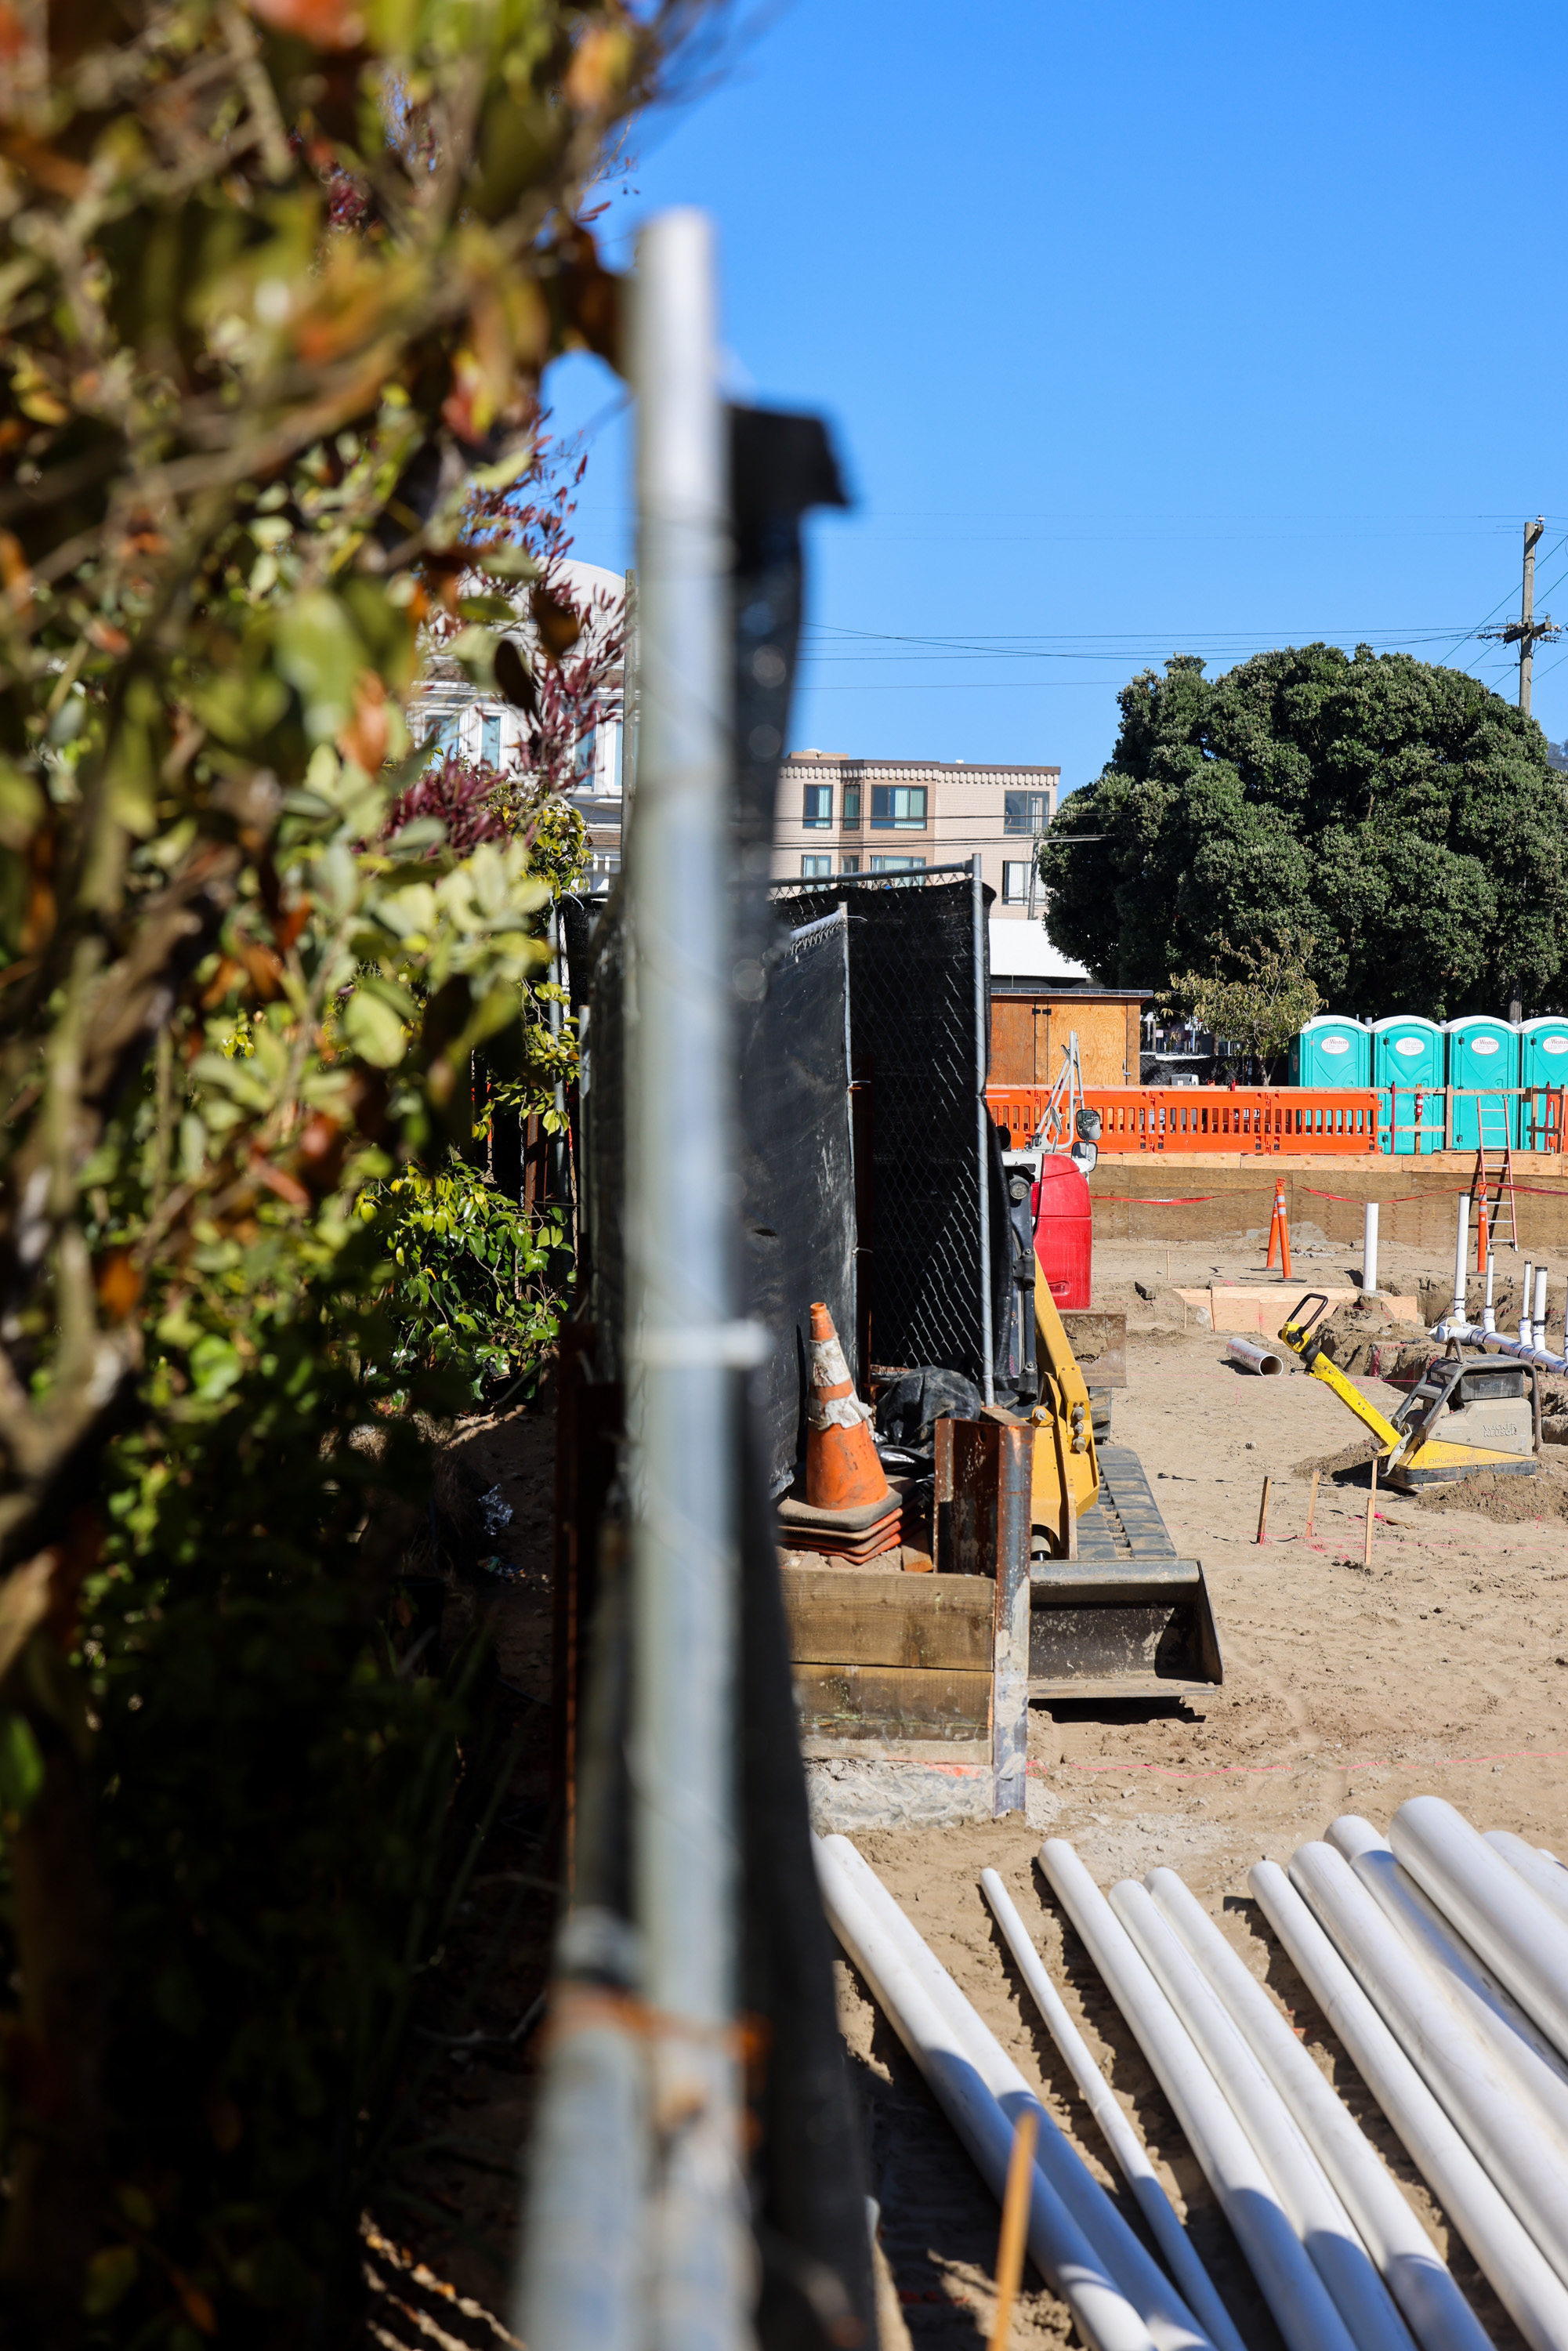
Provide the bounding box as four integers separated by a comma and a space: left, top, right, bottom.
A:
1291, 1843, 1568, 2283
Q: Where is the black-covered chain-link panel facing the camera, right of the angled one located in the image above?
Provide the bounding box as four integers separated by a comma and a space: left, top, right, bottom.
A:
771, 875, 1006, 1389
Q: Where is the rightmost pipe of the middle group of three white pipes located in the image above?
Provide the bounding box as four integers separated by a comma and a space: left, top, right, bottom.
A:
1147, 1869, 1490, 2351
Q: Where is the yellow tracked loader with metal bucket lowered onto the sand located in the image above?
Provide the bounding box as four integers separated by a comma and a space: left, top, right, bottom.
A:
1030, 1272, 1225, 1700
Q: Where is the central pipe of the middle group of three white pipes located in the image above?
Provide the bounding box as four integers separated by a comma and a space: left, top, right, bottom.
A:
1110, 1878, 1410, 2351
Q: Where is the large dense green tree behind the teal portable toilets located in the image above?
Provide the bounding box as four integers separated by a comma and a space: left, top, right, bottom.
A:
1041, 644, 1568, 1020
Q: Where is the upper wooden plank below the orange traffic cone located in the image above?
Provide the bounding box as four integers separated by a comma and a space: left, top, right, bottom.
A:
778, 1568, 994, 1672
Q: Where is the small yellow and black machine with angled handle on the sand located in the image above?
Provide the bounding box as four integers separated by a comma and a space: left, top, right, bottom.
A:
1279, 1291, 1540, 1493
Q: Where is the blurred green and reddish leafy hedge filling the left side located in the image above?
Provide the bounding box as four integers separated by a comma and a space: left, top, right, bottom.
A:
0, 0, 703, 2351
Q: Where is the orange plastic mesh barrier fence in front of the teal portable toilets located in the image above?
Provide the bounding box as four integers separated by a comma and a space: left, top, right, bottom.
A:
985, 1086, 1568, 1157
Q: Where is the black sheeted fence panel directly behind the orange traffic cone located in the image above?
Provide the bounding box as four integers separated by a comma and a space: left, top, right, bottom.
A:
741, 907, 858, 1495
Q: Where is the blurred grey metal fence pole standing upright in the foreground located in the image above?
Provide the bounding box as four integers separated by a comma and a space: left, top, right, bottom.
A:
625, 212, 750, 2351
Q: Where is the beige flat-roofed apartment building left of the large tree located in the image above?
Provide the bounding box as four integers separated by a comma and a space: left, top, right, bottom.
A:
773, 750, 1063, 922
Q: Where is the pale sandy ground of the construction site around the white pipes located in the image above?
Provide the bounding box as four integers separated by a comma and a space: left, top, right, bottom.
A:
839, 1232, 1568, 2351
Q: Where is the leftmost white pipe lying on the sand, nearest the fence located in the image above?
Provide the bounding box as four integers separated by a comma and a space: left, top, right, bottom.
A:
816, 1838, 1154, 2351
